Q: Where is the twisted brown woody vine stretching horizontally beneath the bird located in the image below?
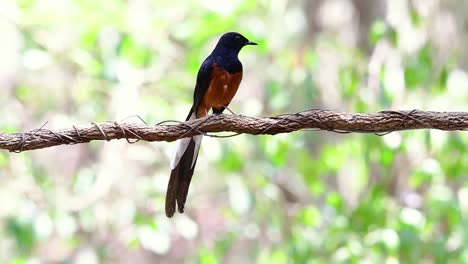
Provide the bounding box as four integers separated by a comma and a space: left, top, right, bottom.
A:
0, 109, 468, 152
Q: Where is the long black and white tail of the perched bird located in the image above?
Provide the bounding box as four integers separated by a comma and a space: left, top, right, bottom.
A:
166, 109, 202, 217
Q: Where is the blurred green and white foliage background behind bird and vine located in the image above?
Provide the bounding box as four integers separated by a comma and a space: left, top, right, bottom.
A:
0, 0, 468, 264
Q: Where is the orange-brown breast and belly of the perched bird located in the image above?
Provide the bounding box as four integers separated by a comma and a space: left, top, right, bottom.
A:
197, 64, 242, 118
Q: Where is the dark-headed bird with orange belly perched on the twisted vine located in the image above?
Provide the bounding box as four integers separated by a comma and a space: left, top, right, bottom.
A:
165, 32, 258, 218
